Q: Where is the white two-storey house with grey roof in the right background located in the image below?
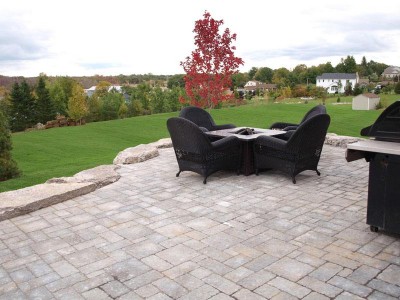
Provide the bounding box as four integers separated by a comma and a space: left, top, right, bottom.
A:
316, 73, 359, 94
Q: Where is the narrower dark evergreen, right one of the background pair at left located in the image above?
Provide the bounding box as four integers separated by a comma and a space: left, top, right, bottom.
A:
36, 76, 56, 124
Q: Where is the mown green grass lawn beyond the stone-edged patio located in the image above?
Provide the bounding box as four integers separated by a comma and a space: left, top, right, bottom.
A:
0, 97, 396, 192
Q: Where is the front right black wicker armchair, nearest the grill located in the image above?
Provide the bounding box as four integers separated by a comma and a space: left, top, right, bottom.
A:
254, 114, 330, 183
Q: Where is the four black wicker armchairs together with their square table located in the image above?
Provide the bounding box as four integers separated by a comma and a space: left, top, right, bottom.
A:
167, 105, 330, 184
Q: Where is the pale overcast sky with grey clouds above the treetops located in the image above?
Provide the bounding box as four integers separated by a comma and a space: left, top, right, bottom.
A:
0, 0, 400, 77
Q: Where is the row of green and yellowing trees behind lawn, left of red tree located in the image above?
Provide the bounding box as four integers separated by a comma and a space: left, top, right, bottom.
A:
0, 74, 184, 132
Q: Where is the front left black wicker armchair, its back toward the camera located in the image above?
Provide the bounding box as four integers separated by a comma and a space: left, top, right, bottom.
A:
167, 117, 241, 184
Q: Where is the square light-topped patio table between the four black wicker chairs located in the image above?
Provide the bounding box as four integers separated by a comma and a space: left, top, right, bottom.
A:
205, 127, 286, 176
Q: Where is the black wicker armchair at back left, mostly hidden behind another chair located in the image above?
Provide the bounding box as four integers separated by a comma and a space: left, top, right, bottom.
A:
179, 106, 236, 131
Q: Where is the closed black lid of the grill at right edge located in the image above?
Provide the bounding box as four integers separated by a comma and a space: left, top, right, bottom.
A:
360, 100, 400, 143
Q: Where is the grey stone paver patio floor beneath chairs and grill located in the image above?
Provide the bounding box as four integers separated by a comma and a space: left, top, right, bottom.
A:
0, 145, 400, 300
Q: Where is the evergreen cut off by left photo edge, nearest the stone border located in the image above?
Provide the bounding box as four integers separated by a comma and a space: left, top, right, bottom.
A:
0, 110, 20, 181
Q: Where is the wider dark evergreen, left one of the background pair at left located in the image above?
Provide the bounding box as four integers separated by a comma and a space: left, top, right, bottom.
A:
10, 80, 35, 131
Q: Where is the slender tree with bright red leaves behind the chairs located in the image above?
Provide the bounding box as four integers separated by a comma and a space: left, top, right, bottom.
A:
180, 11, 244, 108
